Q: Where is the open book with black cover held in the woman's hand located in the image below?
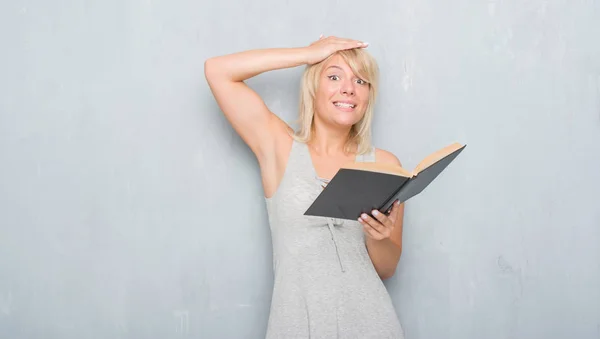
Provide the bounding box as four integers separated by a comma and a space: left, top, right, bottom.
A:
304, 143, 466, 220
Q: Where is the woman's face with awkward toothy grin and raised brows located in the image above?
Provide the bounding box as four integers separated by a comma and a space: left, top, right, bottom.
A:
315, 55, 369, 127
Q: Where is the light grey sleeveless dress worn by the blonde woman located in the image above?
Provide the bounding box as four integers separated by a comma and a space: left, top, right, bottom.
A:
265, 140, 404, 339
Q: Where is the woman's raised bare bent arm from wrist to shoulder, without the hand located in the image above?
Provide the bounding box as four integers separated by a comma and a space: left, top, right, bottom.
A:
204, 48, 307, 158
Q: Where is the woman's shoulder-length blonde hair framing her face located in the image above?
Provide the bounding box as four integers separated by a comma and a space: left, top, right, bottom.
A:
292, 48, 379, 154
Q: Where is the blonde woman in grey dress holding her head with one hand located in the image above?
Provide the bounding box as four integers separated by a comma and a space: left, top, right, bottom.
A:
205, 37, 404, 339
